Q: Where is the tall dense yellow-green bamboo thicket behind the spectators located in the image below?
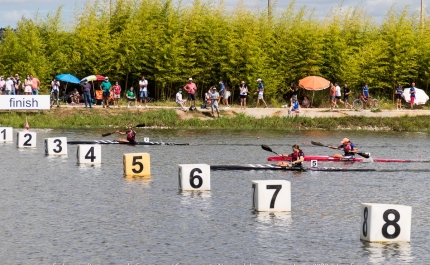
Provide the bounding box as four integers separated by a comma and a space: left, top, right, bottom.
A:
0, 0, 430, 105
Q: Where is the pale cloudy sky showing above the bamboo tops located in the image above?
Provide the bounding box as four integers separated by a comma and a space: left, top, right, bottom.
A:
0, 0, 424, 28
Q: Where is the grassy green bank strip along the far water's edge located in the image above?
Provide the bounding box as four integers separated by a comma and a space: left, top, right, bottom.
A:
0, 108, 430, 131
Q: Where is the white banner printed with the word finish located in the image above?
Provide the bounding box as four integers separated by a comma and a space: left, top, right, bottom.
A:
0, 95, 51, 110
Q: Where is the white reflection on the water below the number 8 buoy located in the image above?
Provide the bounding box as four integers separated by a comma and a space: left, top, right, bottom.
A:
363, 242, 414, 264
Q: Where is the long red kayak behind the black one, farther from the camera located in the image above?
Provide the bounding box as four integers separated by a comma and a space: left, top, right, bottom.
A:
267, 156, 429, 163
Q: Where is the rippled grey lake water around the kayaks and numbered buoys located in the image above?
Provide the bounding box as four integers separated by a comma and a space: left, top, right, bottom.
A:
0, 129, 430, 264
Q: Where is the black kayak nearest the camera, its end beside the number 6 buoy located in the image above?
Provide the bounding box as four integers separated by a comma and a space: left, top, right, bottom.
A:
210, 164, 376, 172
